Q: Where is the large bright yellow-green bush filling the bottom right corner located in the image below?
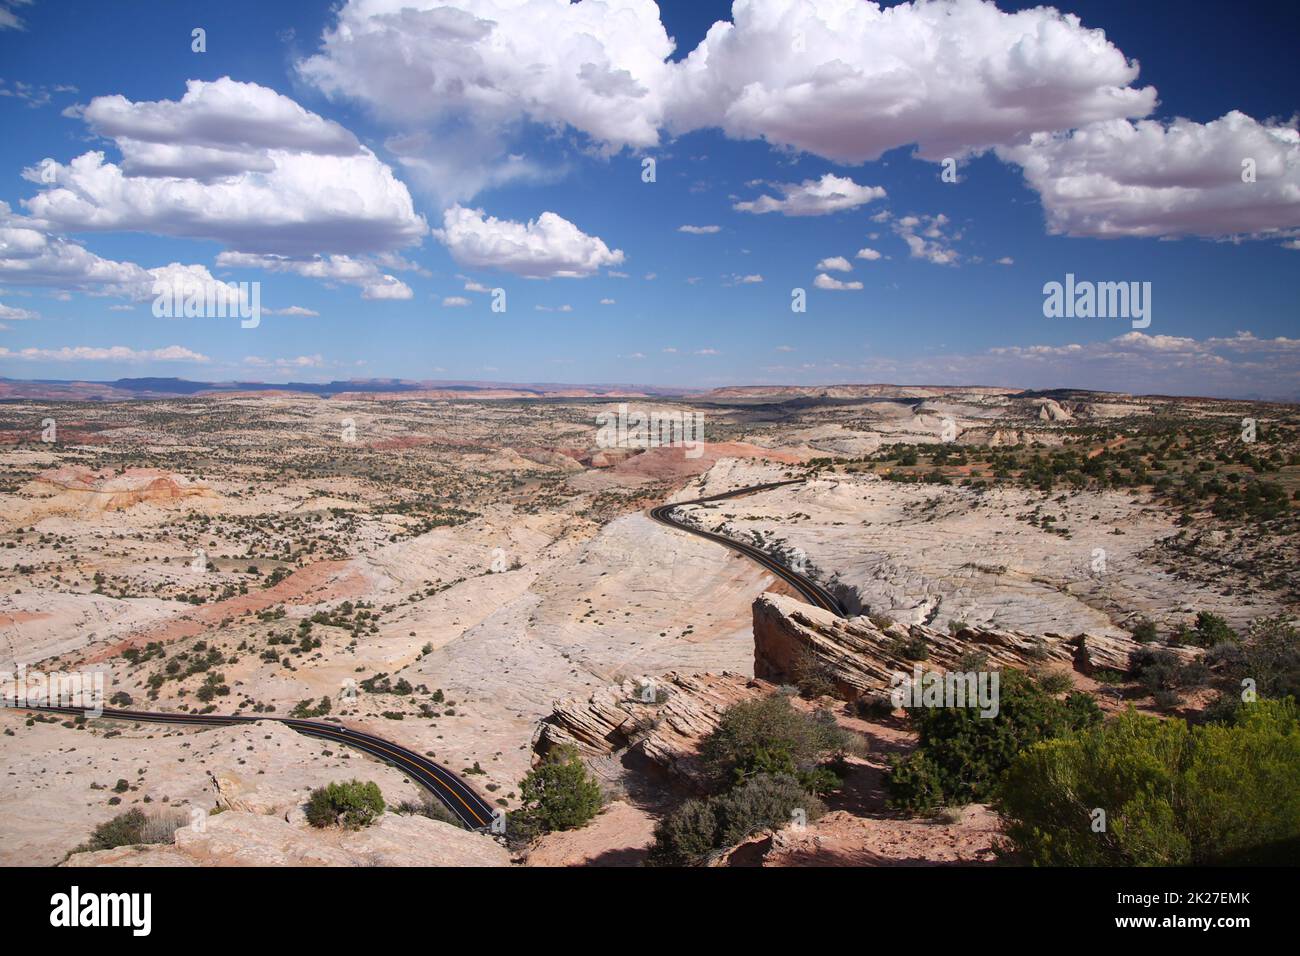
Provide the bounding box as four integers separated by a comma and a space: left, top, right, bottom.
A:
998, 700, 1300, 866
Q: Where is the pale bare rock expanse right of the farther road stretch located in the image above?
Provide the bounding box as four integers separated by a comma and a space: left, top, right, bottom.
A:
676, 462, 1282, 637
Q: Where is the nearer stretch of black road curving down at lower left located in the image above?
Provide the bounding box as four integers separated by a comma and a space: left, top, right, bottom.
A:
17, 706, 494, 830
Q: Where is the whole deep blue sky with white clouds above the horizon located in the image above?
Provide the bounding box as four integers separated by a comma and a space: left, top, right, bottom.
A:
0, 0, 1300, 399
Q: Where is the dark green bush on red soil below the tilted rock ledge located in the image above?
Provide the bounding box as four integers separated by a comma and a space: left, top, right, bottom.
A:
887, 670, 1101, 813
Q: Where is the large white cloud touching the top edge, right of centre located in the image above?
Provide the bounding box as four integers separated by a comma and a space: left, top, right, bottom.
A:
670, 0, 1156, 163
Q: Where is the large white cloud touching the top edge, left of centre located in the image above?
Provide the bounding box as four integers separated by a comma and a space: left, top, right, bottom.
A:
298, 0, 673, 148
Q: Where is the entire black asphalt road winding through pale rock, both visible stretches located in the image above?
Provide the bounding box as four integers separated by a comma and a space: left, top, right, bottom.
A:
18, 479, 846, 830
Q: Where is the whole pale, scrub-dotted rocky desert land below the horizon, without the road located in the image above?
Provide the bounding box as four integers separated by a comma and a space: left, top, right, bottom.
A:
0, 385, 1300, 866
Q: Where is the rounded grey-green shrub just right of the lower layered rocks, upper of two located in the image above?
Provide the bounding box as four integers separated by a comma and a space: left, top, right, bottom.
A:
701, 693, 858, 792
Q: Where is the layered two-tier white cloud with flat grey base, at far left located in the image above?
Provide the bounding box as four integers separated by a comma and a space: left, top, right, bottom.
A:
23, 79, 428, 255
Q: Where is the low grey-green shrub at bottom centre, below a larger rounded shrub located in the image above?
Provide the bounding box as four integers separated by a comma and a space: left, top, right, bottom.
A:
649, 774, 826, 866
